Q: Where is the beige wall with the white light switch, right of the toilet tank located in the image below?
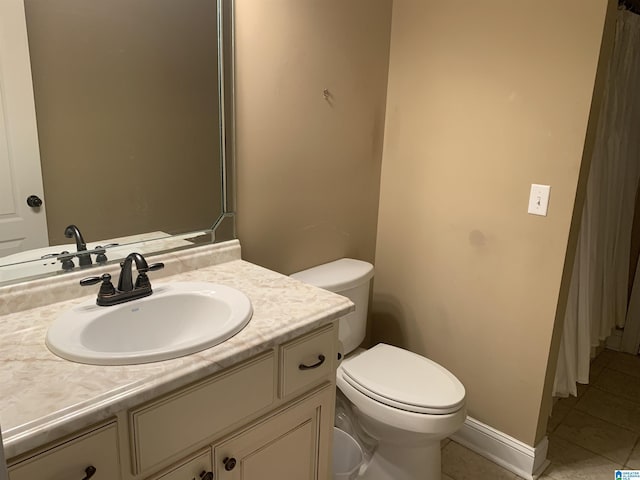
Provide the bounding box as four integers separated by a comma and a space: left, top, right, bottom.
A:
372, 0, 607, 445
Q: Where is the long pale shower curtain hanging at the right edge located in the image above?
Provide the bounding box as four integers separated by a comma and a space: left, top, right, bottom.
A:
553, 8, 640, 397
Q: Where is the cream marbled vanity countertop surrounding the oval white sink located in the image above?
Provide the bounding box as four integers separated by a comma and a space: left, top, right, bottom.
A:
0, 260, 353, 458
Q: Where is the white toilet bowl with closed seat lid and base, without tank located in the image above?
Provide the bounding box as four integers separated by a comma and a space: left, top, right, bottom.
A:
336, 343, 466, 480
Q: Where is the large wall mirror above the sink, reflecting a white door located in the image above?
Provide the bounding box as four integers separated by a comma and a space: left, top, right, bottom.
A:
0, 0, 235, 284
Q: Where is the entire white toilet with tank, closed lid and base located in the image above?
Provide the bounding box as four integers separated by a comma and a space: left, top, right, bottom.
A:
291, 258, 466, 480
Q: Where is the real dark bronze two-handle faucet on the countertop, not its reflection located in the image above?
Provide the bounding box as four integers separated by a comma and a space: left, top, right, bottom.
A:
80, 252, 164, 307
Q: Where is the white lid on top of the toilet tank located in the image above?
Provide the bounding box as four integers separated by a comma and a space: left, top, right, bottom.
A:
291, 258, 373, 292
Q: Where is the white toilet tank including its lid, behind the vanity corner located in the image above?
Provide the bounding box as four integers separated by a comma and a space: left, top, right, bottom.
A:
291, 258, 373, 355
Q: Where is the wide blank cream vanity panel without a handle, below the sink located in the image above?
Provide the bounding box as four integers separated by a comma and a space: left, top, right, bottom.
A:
129, 351, 275, 473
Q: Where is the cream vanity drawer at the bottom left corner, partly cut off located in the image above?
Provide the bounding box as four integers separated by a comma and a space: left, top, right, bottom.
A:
9, 424, 120, 480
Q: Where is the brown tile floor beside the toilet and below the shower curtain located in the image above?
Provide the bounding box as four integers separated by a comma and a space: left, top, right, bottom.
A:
442, 350, 640, 480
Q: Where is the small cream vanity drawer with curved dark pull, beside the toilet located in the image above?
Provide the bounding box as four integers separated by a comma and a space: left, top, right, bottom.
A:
280, 323, 338, 397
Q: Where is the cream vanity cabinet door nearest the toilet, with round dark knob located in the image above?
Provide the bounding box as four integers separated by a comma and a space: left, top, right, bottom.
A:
214, 384, 335, 480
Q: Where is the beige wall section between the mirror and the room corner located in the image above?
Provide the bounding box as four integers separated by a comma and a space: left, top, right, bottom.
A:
236, 0, 391, 274
